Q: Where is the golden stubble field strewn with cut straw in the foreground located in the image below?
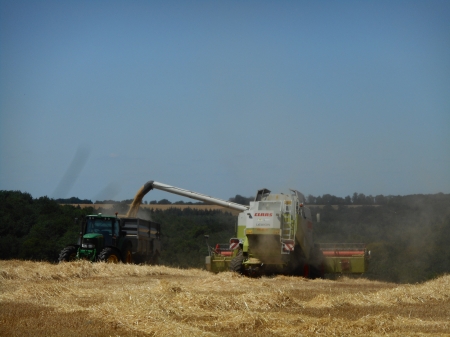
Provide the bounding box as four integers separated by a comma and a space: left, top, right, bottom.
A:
0, 261, 450, 336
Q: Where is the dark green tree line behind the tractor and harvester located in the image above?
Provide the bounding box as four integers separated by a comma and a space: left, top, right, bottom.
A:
0, 191, 450, 283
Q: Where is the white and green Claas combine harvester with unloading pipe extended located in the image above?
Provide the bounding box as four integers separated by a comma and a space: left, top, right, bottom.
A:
141, 181, 370, 278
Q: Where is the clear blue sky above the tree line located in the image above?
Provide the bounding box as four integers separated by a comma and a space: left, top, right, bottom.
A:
0, 0, 450, 201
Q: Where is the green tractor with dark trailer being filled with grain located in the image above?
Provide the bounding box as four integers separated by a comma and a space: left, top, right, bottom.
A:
58, 213, 161, 264
